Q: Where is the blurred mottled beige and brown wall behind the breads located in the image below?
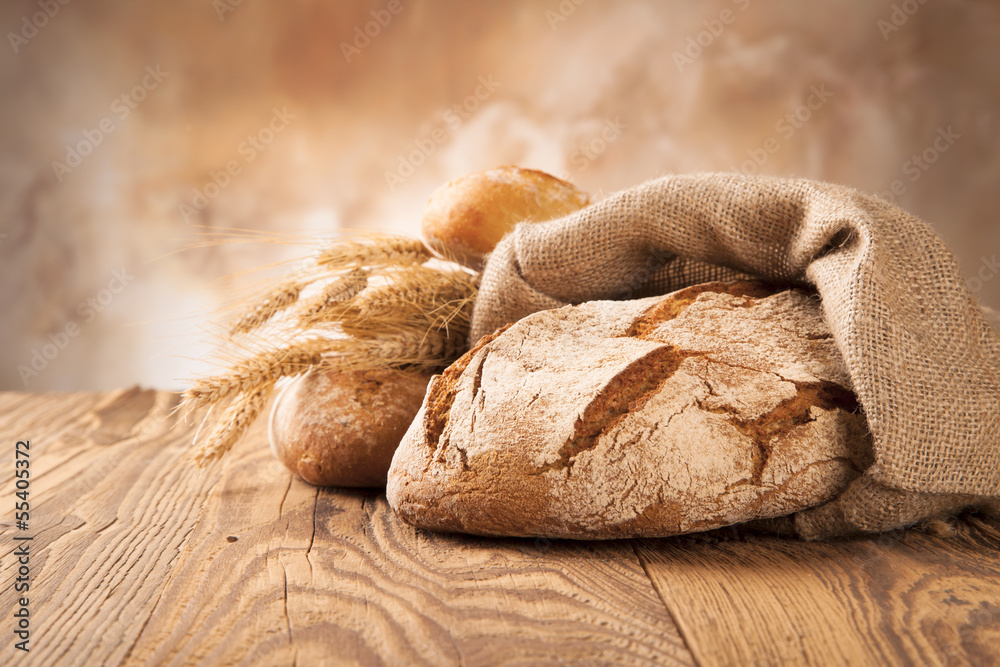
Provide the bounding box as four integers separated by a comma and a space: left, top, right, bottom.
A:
0, 0, 1000, 390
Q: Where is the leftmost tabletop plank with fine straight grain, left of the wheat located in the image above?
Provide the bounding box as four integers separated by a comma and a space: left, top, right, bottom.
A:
0, 389, 217, 665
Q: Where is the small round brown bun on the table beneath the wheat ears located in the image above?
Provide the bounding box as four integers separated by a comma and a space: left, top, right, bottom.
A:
269, 369, 431, 487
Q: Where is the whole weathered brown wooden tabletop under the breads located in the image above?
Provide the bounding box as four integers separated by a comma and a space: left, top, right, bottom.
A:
0, 388, 1000, 666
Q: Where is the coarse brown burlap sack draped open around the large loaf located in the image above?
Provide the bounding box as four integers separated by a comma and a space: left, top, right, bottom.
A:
470, 174, 1000, 539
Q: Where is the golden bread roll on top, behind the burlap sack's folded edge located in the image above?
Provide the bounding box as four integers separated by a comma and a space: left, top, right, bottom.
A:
420, 167, 590, 271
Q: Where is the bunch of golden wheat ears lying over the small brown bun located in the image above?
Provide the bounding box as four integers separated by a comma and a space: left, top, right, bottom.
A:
188, 236, 479, 465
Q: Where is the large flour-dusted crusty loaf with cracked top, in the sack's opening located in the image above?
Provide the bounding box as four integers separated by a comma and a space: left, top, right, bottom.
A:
387, 282, 872, 539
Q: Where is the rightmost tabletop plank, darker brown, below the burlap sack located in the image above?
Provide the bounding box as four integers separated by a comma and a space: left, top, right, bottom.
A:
636, 517, 1000, 665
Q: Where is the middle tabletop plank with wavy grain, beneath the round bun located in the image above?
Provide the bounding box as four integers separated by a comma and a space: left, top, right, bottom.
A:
131, 430, 690, 665
